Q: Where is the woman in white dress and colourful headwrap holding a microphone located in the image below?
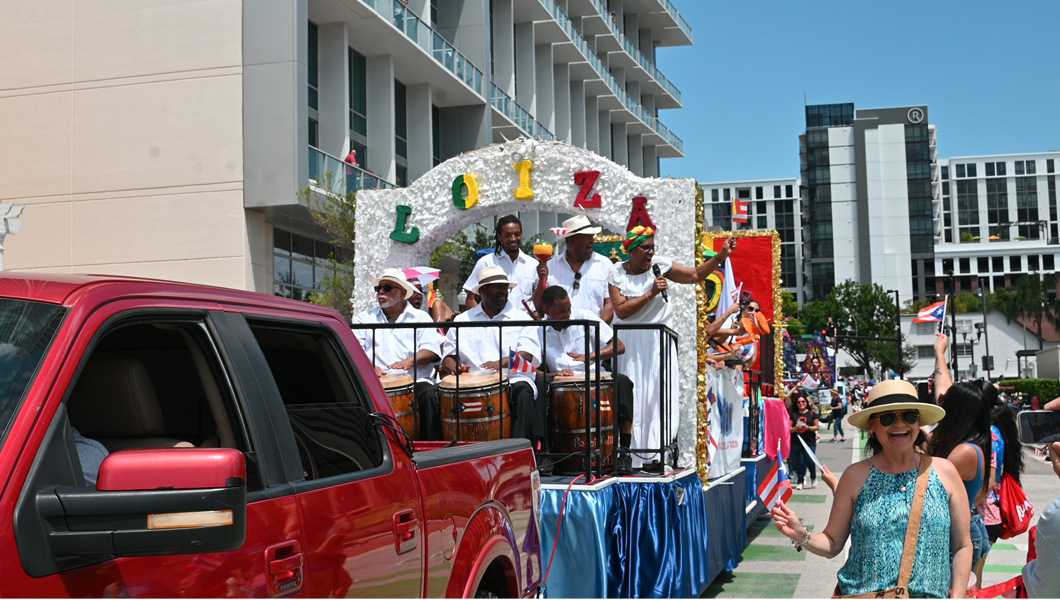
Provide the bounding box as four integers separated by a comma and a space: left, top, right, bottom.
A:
607, 226, 736, 467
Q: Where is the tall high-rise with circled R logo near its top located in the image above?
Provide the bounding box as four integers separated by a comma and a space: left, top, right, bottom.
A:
799, 104, 940, 300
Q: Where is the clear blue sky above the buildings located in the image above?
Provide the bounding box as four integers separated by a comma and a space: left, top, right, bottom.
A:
657, 0, 1060, 182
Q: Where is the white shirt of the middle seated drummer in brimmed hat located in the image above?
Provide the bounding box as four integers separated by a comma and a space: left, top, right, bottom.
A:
442, 301, 541, 395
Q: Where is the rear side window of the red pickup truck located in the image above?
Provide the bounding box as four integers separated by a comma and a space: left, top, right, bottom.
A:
247, 319, 384, 480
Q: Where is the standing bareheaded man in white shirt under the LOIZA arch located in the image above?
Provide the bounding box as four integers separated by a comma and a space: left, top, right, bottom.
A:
464, 214, 537, 318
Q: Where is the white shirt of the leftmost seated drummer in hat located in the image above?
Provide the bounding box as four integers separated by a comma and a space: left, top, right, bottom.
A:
353, 301, 444, 383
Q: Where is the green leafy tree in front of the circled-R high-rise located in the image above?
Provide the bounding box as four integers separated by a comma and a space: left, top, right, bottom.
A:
799, 281, 916, 378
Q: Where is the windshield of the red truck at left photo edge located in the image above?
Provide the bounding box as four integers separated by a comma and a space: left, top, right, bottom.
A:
0, 298, 67, 438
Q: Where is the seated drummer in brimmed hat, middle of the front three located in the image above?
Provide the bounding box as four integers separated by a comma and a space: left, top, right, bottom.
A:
442, 266, 545, 447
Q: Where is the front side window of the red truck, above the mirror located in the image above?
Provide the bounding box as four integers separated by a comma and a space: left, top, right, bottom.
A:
67, 322, 262, 491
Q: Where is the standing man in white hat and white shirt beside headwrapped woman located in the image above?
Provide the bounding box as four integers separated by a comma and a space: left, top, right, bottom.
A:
534, 215, 614, 323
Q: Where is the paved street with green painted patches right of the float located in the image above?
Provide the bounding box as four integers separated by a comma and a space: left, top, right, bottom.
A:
704, 415, 1060, 598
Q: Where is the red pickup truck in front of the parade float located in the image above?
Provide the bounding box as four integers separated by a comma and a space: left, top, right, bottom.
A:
0, 275, 541, 598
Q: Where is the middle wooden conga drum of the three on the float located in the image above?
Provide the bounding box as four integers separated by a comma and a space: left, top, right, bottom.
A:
439, 371, 512, 442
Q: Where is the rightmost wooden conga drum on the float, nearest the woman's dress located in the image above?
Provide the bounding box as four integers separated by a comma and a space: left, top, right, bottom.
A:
548, 374, 615, 475
